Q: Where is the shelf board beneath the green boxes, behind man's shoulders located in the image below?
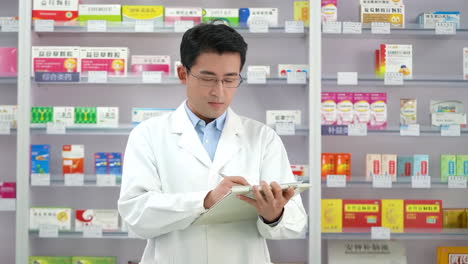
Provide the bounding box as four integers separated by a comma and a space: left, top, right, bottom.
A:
31, 124, 309, 136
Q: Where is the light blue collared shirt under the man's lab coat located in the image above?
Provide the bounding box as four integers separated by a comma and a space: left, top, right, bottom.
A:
184, 103, 226, 161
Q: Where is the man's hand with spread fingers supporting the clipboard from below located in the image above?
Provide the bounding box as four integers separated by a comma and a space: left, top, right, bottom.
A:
237, 181, 294, 223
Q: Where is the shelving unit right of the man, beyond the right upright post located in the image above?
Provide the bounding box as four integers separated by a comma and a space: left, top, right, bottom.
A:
322, 0, 468, 263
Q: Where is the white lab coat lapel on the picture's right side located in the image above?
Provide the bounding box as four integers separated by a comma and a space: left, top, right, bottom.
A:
213, 109, 243, 172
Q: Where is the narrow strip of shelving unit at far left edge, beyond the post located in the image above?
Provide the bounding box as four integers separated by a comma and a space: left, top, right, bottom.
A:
0, 0, 18, 263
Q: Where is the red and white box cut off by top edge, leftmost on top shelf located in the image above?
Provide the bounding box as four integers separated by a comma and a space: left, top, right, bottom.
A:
32, 0, 80, 24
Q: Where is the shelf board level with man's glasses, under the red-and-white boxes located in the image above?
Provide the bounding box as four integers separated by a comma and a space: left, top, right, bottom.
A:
34, 75, 306, 86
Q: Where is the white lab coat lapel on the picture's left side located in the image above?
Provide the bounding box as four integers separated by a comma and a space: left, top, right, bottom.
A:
171, 102, 212, 167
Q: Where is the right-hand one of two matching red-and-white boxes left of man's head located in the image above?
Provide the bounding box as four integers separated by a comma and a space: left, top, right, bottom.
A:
80, 47, 128, 77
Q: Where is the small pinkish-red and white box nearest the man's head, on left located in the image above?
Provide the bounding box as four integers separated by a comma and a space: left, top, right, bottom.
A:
131, 55, 171, 76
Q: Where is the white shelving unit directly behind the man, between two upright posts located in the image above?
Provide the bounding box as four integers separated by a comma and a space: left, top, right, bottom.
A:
14, 0, 321, 264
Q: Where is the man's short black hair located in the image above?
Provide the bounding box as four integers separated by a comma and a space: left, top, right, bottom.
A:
180, 24, 247, 70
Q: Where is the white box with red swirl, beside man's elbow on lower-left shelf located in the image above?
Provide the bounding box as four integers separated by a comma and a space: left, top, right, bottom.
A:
75, 209, 119, 231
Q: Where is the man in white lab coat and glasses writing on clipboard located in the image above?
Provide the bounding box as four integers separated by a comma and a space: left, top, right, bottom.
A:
118, 24, 307, 264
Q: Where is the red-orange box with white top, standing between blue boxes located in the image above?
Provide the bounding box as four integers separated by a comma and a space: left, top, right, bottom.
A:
62, 145, 85, 177
